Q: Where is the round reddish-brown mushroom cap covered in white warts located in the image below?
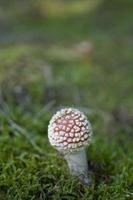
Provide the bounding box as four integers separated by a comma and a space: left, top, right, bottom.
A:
48, 108, 92, 153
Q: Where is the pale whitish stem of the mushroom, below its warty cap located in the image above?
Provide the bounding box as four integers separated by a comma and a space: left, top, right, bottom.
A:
65, 149, 92, 186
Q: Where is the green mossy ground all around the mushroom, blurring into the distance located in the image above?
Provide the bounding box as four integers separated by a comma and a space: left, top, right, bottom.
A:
0, 0, 133, 200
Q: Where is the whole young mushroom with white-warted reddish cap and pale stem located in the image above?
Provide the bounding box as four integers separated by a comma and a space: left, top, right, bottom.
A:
48, 108, 92, 185
